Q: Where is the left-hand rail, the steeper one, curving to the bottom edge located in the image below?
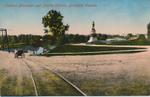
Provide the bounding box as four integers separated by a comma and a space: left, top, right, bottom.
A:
22, 60, 38, 96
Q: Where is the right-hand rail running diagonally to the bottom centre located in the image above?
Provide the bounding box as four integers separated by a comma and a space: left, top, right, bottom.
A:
26, 59, 87, 96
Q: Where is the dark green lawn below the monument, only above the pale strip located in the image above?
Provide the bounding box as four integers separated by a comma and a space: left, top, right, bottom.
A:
50, 45, 144, 53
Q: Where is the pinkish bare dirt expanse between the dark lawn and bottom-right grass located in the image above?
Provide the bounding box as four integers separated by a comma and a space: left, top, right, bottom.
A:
28, 47, 150, 78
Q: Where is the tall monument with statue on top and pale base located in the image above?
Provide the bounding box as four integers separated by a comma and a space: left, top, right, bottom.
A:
87, 21, 98, 43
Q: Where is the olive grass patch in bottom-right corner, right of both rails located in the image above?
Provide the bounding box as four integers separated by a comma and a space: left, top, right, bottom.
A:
79, 80, 150, 96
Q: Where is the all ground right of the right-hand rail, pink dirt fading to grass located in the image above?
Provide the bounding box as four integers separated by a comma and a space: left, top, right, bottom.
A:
27, 46, 150, 95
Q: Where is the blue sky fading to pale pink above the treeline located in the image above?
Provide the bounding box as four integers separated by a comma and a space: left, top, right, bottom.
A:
0, 0, 150, 35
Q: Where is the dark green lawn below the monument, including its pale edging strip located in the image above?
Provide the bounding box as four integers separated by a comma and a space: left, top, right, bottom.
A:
39, 45, 146, 56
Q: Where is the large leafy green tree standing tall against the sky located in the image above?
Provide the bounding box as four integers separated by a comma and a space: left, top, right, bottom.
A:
42, 10, 69, 45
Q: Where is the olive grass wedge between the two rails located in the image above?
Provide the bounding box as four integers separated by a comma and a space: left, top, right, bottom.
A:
34, 70, 81, 96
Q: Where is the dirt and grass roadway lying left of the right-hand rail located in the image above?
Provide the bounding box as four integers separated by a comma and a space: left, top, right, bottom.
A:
0, 52, 83, 96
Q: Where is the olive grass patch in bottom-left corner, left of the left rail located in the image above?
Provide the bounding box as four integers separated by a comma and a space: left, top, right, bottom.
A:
1, 76, 35, 96
